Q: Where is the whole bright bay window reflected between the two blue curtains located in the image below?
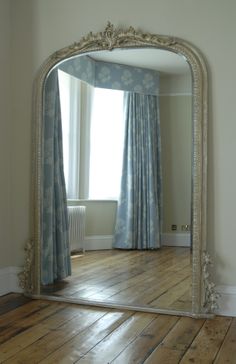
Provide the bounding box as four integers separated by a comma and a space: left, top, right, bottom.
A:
59, 71, 124, 200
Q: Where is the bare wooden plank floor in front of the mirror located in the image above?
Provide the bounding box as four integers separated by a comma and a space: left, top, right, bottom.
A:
0, 294, 236, 364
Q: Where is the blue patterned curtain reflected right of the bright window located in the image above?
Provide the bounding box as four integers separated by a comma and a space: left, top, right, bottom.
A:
114, 93, 162, 249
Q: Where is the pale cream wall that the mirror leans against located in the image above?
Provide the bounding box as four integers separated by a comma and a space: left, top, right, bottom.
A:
3, 0, 236, 285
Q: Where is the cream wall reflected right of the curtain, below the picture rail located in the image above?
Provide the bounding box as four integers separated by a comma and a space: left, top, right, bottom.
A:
160, 95, 192, 233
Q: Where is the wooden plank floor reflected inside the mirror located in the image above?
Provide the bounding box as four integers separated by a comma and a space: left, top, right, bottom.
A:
42, 247, 191, 311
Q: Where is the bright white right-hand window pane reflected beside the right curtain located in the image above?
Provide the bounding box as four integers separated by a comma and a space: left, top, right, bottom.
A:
89, 88, 124, 199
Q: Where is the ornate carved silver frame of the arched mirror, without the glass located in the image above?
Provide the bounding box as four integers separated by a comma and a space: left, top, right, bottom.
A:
19, 23, 217, 317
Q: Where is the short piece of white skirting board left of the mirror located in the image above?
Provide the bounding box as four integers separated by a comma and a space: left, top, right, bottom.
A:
0, 267, 22, 296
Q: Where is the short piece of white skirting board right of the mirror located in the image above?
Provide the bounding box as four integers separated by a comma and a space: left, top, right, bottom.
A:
215, 286, 236, 317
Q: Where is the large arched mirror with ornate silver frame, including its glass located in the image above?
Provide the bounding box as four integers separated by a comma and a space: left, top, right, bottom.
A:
20, 23, 217, 317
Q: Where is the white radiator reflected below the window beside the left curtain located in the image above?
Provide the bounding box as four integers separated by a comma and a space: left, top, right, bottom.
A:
68, 206, 86, 252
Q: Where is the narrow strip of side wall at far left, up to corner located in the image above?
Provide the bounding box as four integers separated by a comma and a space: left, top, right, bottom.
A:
0, 0, 12, 267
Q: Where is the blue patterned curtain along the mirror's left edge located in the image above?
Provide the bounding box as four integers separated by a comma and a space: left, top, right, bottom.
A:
41, 70, 71, 285
